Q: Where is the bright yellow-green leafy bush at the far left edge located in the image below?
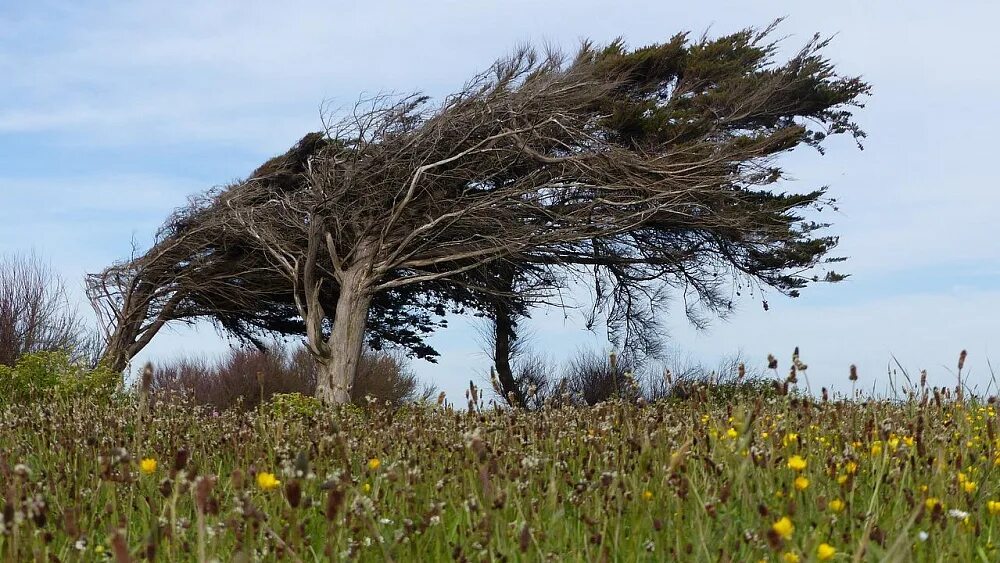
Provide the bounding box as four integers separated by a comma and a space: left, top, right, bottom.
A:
0, 352, 121, 402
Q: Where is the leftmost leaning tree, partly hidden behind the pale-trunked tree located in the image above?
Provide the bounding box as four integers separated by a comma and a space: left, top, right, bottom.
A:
87, 134, 472, 371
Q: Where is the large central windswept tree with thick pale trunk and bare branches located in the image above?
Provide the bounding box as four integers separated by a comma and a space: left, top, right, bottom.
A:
227, 24, 867, 403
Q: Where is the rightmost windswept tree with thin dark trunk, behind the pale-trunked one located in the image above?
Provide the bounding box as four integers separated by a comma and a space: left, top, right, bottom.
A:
476, 27, 869, 406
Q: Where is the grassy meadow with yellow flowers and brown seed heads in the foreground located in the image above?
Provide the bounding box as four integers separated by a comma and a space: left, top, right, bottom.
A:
0, 376, 1000, 562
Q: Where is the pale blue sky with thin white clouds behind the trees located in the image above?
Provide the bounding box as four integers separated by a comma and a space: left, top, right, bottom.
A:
0, 0, 1000, 401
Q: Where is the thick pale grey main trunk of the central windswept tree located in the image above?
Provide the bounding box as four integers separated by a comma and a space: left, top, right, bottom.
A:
316, 268, 372, 405
